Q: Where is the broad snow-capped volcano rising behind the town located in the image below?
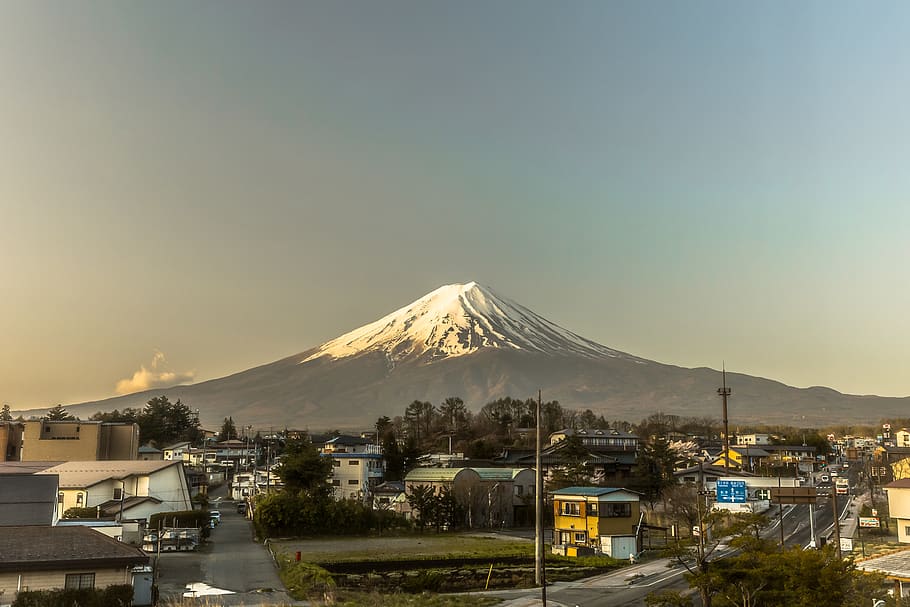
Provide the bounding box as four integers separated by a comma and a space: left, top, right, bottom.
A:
57, 282, 910, 431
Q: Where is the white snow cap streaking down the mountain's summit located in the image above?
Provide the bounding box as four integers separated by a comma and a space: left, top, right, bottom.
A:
301, 282, 634, 362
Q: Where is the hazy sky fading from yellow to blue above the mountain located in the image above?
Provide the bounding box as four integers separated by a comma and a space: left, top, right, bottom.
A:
0, 0, 910, 409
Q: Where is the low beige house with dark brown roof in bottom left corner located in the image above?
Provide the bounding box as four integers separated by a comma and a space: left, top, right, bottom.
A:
0, 526, 149, 604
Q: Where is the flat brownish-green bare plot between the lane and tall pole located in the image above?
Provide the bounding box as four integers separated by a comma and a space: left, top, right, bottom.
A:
272, 533, 534, 563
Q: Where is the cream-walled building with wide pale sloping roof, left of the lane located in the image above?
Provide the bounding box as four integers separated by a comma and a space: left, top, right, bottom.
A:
38, 460, 193, 519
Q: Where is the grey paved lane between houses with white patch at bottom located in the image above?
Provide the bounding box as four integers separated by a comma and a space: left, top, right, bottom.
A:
158, 500, 295, 606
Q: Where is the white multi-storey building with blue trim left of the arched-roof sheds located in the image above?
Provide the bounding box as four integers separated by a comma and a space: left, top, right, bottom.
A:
320, 435, 385, 500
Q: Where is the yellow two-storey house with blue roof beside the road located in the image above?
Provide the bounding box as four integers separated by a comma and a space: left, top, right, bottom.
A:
550, 487, 641, 551
